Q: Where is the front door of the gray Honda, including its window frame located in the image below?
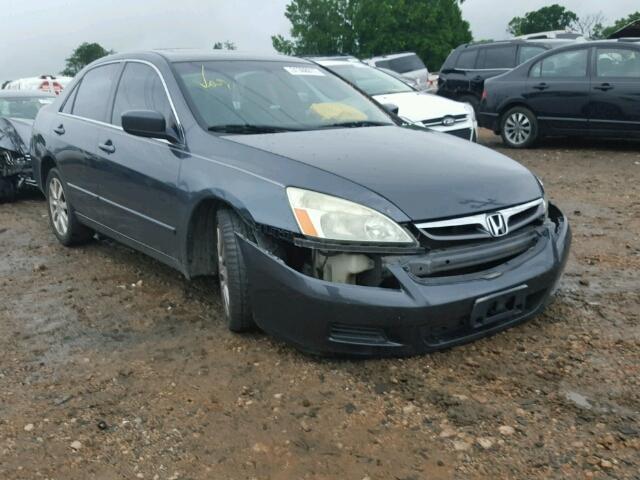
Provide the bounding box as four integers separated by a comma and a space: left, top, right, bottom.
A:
98, 61, 184, 259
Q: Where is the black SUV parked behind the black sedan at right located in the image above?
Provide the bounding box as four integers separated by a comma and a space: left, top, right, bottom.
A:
438, 38, 576, 111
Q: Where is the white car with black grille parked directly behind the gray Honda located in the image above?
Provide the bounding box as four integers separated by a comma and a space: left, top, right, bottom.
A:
312, 57, 478, 142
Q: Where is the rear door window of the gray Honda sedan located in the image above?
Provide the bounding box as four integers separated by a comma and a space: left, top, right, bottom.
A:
73, 63, 120, 122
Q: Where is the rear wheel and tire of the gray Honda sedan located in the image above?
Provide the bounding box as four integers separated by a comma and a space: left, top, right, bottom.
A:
47, 168, 93, 247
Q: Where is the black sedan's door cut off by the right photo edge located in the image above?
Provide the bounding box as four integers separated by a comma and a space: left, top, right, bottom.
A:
589, 46, 640, 135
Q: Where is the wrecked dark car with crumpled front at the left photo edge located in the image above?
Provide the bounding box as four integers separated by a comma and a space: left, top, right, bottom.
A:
0, 90, 55, 202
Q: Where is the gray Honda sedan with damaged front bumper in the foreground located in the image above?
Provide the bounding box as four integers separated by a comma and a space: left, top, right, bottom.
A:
31, 50, 571, 356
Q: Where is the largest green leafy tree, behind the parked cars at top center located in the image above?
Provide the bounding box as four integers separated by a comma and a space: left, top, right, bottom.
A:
272, 0, 472, 69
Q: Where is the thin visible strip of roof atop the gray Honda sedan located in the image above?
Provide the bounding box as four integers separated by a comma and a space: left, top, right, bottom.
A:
99, 48, 306, 63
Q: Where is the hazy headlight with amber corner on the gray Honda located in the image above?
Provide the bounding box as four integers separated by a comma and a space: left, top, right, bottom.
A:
287, 187, 415, 243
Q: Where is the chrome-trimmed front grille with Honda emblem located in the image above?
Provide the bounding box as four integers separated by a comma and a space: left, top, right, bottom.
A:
415, 198, 546, 242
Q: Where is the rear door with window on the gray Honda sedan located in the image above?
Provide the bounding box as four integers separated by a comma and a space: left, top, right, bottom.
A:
56, 63, 121, 214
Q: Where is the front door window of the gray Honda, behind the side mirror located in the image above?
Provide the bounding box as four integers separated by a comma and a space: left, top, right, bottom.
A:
111, 62, 174, 126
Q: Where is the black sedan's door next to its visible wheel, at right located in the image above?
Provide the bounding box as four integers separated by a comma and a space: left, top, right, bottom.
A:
525, 47, 590, 133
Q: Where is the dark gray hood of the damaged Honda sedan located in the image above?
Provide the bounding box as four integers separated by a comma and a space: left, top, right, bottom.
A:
224, 126, 542, 220
